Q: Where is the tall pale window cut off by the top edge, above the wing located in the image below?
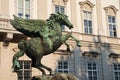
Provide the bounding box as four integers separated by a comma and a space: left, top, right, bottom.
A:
18, 0, 30, 19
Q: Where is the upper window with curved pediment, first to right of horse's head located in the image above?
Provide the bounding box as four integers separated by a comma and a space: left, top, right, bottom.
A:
79, 0, 94, 34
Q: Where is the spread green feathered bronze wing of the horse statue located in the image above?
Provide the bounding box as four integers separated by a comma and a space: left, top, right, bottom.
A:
10, 15, 46, 37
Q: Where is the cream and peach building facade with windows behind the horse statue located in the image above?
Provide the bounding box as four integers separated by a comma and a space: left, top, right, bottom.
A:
0, 0, 120, 80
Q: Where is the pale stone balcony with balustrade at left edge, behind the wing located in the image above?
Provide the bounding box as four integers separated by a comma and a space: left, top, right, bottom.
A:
0, 15, 24, 46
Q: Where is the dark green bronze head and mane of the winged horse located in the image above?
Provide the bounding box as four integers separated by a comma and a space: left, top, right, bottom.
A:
49, 13, 73, 29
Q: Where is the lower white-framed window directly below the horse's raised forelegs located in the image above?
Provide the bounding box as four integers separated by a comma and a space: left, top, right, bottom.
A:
57, 61, 69, 73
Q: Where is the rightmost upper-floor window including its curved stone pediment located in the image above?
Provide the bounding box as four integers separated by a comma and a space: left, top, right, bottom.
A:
104, 5, 117, 37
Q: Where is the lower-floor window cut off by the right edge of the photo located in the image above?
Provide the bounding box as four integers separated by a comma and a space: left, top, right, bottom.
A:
113, 64, 120, 80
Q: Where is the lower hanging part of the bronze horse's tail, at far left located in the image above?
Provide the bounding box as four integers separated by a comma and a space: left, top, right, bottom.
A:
12, 51, 24, 72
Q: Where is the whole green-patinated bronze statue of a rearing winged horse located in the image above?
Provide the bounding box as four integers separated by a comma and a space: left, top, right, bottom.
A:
10, 13, 80, 74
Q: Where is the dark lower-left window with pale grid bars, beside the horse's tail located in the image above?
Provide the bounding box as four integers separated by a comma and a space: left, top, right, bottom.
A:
18, 61, 32, 80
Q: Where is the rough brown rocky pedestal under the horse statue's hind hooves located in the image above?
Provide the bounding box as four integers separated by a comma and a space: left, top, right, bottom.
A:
32, 73, 78, 80
